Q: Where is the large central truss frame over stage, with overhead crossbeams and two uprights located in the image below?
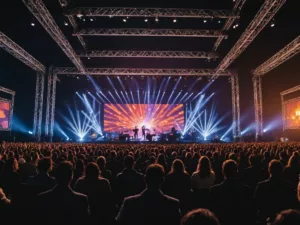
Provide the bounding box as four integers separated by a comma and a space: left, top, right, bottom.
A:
15, 0, 286, 141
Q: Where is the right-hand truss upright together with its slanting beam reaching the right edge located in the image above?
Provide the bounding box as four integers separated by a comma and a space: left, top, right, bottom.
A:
253, 36, 300, 138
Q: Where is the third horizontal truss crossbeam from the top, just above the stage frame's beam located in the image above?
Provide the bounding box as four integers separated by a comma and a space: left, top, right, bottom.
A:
78, 50, 219, 59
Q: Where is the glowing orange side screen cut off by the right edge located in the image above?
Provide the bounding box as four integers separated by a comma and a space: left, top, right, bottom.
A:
285, 98, 300, 129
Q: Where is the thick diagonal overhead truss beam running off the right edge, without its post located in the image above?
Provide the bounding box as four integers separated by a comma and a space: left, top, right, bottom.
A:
253, 36, 300, 76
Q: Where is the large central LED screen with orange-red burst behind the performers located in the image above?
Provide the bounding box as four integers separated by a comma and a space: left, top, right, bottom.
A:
104, 104, 184, 133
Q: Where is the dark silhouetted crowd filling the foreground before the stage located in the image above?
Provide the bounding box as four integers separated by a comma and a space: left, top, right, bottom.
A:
0, 142, 300, 225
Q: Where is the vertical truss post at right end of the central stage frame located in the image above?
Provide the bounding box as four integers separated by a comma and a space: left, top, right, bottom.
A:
231, 74, 241, 139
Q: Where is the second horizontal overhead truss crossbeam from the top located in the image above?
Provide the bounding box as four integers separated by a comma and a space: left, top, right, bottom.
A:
74, 28, 227, 38
